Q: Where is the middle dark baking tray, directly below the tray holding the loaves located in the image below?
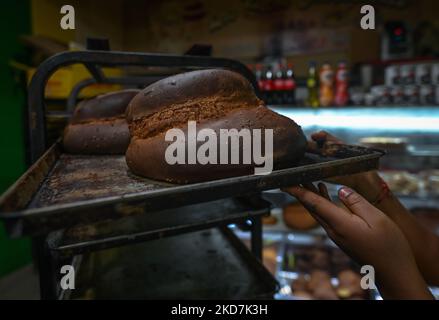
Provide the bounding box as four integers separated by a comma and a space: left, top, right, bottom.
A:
47, 197, 270, 258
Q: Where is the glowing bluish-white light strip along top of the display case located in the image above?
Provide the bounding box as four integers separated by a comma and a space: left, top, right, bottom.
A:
275, 109, 439, 132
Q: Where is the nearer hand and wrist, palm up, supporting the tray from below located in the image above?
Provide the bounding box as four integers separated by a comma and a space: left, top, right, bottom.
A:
284, 183, 432, 299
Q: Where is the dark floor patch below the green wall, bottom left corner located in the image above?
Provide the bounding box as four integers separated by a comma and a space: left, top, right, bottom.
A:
0, 265, 40, 300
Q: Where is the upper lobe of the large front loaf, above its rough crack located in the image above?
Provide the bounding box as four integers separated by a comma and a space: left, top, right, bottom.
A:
127, 69, 263, 122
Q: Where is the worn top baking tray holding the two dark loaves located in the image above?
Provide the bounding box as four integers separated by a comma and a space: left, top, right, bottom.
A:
0, 141, 384, 237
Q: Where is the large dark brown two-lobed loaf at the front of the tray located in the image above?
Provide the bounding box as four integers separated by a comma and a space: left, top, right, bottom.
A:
126, 69, 306, 183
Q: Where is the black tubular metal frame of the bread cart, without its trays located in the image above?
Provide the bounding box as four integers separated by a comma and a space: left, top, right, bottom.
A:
28, 51, 264, 299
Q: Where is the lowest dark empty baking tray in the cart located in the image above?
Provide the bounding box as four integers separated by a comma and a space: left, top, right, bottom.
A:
63, 228, 279, 300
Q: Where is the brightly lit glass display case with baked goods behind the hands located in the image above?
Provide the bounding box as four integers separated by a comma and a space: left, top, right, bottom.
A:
249, 106, 439, 299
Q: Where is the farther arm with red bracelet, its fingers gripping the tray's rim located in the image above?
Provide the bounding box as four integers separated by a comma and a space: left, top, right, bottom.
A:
310, 131, 439, 286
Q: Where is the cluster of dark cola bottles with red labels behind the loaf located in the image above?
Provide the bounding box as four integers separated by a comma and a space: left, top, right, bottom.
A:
249, 63, 296, 105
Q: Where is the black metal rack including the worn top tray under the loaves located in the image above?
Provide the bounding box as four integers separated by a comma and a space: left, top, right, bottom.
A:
0, 51, 383, 299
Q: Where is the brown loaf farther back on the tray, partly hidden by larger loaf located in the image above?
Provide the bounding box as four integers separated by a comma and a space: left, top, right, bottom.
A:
63, 89, 140, 154
